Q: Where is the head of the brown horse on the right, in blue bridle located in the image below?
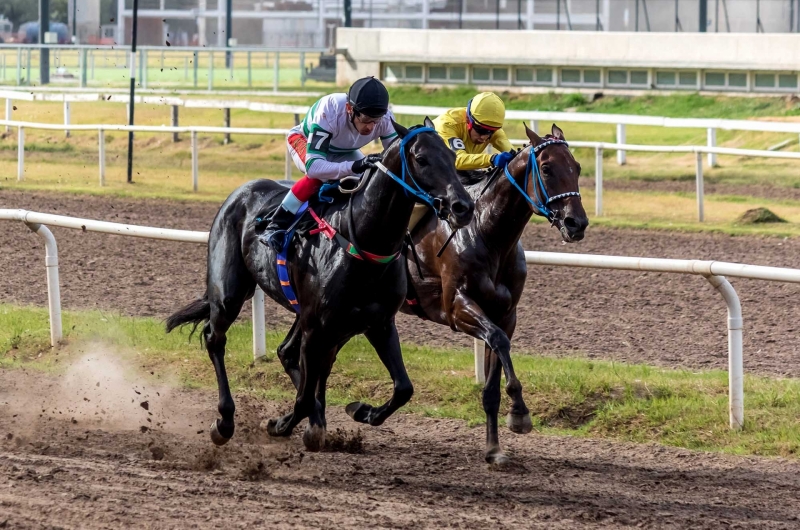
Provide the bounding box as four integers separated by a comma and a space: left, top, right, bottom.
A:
508, 124, 589, 243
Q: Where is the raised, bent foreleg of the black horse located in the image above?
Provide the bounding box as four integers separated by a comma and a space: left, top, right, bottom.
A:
345, 319, 414, 426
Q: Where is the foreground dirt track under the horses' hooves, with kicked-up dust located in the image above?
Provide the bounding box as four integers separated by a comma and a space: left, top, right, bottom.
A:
0, 364, 800, 529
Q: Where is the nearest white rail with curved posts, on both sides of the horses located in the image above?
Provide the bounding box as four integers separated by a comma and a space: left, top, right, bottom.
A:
7, 209, 800, 429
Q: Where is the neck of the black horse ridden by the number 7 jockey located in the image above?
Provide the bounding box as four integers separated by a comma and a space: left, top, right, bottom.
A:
348, 151, 414, 256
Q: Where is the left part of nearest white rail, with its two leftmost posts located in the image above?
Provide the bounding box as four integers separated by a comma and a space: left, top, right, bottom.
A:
0, 209, 267, 359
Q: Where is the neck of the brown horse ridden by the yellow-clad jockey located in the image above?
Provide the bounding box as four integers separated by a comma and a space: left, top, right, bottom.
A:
475, 157, 533, 256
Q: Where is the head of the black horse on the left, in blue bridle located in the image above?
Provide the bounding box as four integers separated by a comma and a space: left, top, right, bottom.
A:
384, 118, 475, 228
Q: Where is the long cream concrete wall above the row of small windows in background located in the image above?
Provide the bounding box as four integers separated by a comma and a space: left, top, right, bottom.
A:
336, 27, 800, 85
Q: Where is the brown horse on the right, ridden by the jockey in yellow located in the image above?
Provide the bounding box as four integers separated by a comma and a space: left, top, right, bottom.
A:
401, 125, 589, 463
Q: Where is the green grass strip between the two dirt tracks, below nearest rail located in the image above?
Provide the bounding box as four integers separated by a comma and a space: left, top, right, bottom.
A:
0, 305, 800, 457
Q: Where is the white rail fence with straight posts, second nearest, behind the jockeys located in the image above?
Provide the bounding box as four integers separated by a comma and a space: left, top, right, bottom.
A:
6, 115, 800, 222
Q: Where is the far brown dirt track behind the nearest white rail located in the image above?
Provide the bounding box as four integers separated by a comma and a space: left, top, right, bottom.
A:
0, 190, 800, 376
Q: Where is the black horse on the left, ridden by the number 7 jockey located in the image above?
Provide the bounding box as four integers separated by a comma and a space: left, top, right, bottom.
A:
167, 118, 474, 451
